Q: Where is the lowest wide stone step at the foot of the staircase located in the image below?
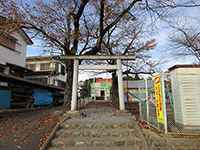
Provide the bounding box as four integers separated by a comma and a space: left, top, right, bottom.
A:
51, 137, 144, 147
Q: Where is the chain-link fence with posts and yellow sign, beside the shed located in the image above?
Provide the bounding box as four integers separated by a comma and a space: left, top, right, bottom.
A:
129, 74, 200, 134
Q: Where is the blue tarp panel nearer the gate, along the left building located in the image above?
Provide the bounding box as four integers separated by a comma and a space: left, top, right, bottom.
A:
33, 89, 53, 105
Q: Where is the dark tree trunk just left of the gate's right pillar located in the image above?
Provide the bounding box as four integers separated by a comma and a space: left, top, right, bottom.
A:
111, 72, 119, 108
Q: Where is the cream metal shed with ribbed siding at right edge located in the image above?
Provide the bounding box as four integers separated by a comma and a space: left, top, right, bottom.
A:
169, 65, 200, 129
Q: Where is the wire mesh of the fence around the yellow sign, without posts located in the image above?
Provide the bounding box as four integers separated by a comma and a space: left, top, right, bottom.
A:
140, 79, 200, 134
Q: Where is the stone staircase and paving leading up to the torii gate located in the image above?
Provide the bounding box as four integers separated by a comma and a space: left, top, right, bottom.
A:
48, 107, 148, 150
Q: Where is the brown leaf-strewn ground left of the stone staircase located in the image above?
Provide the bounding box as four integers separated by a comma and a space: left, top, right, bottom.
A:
0, 108, 62, 150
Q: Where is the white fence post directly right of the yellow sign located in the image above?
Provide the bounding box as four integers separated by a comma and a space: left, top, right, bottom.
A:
161, 72, 168, 134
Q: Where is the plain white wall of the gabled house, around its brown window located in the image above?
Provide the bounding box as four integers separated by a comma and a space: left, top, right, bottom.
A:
0, 32, 27, 67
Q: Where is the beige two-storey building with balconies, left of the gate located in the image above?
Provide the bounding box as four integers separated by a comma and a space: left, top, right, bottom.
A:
26, 56, 66, 87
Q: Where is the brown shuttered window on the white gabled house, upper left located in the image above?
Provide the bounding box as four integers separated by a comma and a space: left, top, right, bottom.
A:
0, 34, 17, 51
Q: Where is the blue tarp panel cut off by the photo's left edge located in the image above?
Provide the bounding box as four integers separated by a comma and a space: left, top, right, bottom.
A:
0, 89, 11, 108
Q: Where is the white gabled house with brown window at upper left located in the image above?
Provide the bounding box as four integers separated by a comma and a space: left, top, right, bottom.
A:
0, 29, 33, 67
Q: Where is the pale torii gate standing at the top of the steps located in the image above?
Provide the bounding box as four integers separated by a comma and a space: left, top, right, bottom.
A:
60, 55, 135, 111
